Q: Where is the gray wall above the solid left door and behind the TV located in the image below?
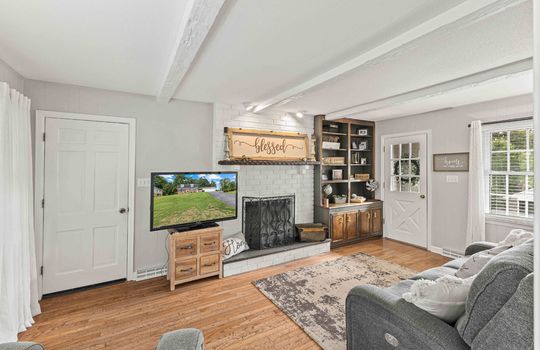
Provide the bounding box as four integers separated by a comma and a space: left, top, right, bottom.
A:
24, 80, 213, 269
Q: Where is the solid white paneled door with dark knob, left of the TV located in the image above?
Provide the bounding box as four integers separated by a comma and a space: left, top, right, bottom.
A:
43, 118, 129, 294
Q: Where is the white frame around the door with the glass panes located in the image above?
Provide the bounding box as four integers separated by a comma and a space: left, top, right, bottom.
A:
379, 129, 433, 251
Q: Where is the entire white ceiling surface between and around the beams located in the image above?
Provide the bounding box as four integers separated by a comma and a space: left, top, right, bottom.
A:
0, 0, 532, 120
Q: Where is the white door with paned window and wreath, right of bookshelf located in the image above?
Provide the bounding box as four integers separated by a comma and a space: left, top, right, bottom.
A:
384, 134, 428, 248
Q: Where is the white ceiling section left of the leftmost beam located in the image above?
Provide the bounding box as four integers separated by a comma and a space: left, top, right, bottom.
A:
0, 0, 187, 95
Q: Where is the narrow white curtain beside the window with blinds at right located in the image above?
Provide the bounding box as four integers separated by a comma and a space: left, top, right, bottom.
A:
466, 120, 486, 245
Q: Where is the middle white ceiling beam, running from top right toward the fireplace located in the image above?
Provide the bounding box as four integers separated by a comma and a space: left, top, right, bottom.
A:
254, 0, 526, 112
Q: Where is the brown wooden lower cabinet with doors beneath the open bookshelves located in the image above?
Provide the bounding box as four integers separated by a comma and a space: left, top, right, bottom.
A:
317, 200, 383, 246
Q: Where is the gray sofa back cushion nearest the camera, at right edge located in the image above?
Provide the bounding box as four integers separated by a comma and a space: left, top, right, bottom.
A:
456, 240, 533, 345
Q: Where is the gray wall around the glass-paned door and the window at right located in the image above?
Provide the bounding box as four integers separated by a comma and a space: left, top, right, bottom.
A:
376, 95, 533, 252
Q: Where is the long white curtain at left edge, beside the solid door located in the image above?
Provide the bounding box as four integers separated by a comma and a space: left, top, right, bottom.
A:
0, 82, 40, 343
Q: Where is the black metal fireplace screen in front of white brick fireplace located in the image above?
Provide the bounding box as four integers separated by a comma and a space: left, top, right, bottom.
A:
242, 195, 296, 249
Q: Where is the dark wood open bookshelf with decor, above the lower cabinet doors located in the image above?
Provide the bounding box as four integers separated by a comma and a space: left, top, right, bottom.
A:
315, 115, 375, 206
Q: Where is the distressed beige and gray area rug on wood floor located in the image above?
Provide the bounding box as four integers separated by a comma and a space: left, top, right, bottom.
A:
253, 253, 417, 350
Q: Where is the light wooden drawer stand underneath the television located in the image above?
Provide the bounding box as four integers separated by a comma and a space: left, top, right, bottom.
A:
167, 226, 223, 290
